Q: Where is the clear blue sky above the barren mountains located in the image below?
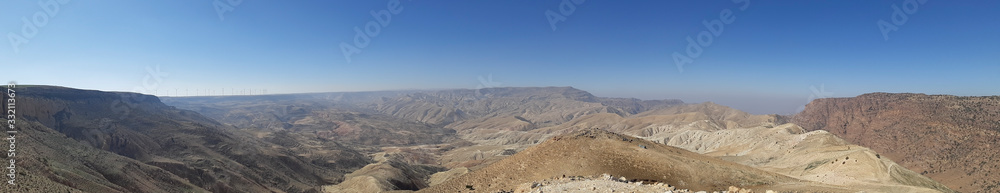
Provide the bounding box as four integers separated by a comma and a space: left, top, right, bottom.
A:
0, 0, 1000, 113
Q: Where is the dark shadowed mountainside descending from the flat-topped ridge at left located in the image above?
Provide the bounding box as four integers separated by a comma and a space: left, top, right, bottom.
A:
5, 86, 369, 192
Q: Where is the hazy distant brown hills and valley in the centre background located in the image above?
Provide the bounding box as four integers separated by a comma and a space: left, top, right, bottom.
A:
163, 87, 692, 170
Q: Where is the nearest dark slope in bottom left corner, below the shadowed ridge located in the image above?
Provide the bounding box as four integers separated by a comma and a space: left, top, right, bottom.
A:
0, 115, 208, 193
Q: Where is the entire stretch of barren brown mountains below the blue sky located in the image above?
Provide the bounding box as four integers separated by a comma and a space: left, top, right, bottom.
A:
0, 86, 1000, 192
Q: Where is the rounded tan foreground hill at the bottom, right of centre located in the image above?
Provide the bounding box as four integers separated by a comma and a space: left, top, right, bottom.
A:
419, 129, 950, 192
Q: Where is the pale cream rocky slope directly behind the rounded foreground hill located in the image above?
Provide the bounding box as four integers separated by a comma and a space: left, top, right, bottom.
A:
428, 103, 952, 192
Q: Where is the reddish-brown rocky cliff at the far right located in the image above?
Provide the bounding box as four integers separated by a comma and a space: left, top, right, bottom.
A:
791, 93, 1000, 192
